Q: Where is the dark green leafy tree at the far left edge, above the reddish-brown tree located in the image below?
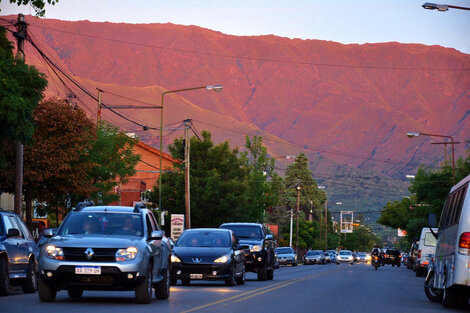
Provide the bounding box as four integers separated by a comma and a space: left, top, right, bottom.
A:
0, 27, 47, 168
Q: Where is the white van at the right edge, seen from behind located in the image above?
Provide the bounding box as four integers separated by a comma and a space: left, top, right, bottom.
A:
424, 175, 470, 307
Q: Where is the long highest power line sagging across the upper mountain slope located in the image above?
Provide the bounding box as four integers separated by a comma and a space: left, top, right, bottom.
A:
31, 24, 470, 71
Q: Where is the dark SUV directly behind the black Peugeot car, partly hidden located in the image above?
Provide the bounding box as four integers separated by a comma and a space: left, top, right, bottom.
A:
220, 223, 276, 280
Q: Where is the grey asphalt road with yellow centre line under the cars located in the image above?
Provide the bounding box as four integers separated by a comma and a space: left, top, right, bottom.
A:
0, 264, 470, 313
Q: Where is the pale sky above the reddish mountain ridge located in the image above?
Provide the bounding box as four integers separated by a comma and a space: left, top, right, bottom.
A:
0, 0, 470, 54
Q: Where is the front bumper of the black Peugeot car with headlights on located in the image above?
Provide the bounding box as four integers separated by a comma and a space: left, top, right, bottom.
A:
171, 262, 234, 280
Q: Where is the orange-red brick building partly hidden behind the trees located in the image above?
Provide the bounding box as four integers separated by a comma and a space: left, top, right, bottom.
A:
112, 141, 179, 206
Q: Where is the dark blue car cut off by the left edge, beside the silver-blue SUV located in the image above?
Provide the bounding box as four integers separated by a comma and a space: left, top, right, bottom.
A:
0, 211, 38, 296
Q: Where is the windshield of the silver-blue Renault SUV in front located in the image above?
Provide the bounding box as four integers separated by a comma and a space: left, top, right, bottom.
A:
59, 212, 143, 237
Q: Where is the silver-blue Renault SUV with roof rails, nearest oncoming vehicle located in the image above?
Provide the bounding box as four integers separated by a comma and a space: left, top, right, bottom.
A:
38, 202, 171, 303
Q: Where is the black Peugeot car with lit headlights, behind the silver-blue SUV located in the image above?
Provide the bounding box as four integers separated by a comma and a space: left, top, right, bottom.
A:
171, 228, 245, 286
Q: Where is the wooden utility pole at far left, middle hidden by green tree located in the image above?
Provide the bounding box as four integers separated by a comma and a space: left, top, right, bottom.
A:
14, 13, 27, 216
